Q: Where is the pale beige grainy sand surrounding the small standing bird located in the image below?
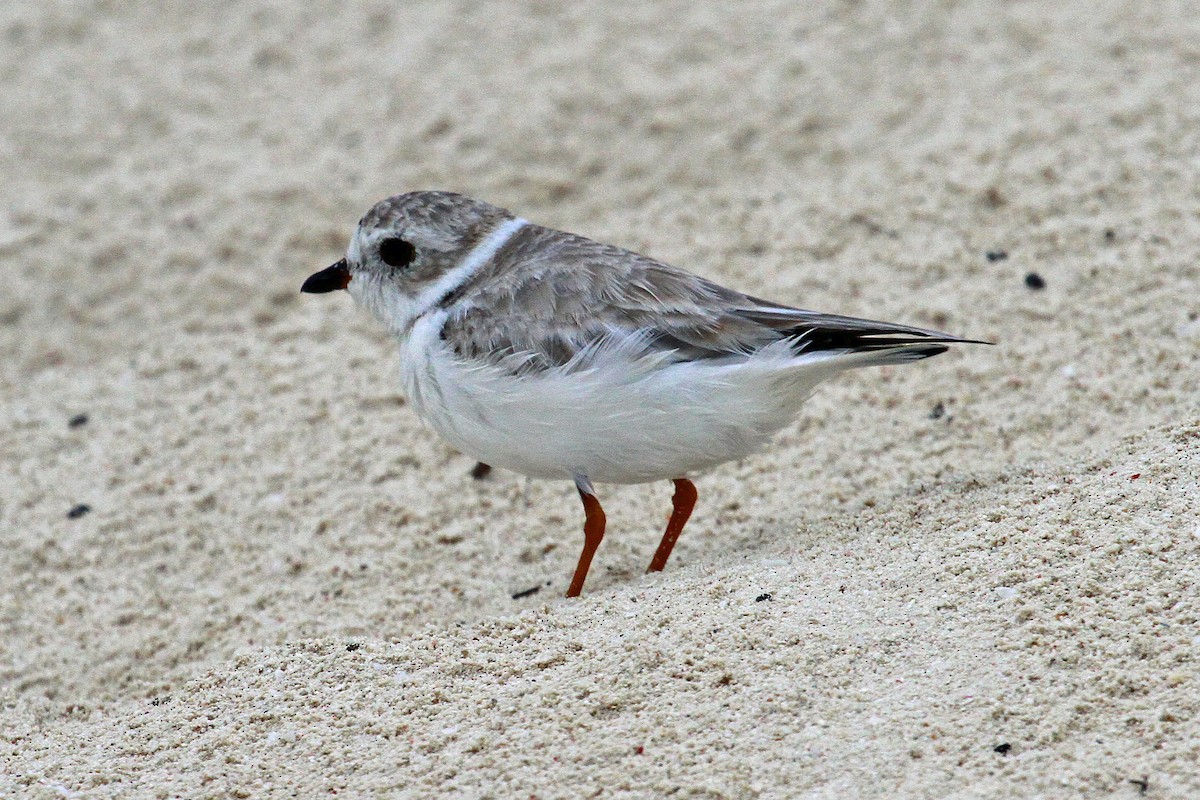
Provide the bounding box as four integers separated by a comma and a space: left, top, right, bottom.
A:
0, 0, 1200, 798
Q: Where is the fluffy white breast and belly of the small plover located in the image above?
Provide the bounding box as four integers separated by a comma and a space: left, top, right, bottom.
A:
401, 313, 840, 483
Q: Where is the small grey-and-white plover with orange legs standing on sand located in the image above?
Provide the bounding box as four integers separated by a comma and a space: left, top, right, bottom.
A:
301, 192, 973, 597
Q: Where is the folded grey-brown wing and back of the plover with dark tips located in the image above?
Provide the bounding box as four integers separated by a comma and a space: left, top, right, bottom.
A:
442, 225, 971, 372
